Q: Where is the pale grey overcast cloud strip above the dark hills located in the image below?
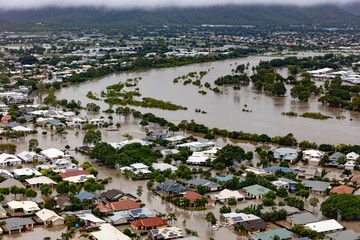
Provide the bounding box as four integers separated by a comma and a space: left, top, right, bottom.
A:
0, 0, 360, 9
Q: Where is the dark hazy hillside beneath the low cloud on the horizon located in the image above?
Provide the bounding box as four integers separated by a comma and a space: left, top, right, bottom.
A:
0, 5, 355, 28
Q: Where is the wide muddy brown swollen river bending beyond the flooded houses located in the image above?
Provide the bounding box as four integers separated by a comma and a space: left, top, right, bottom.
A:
56, 52, 360, 144
